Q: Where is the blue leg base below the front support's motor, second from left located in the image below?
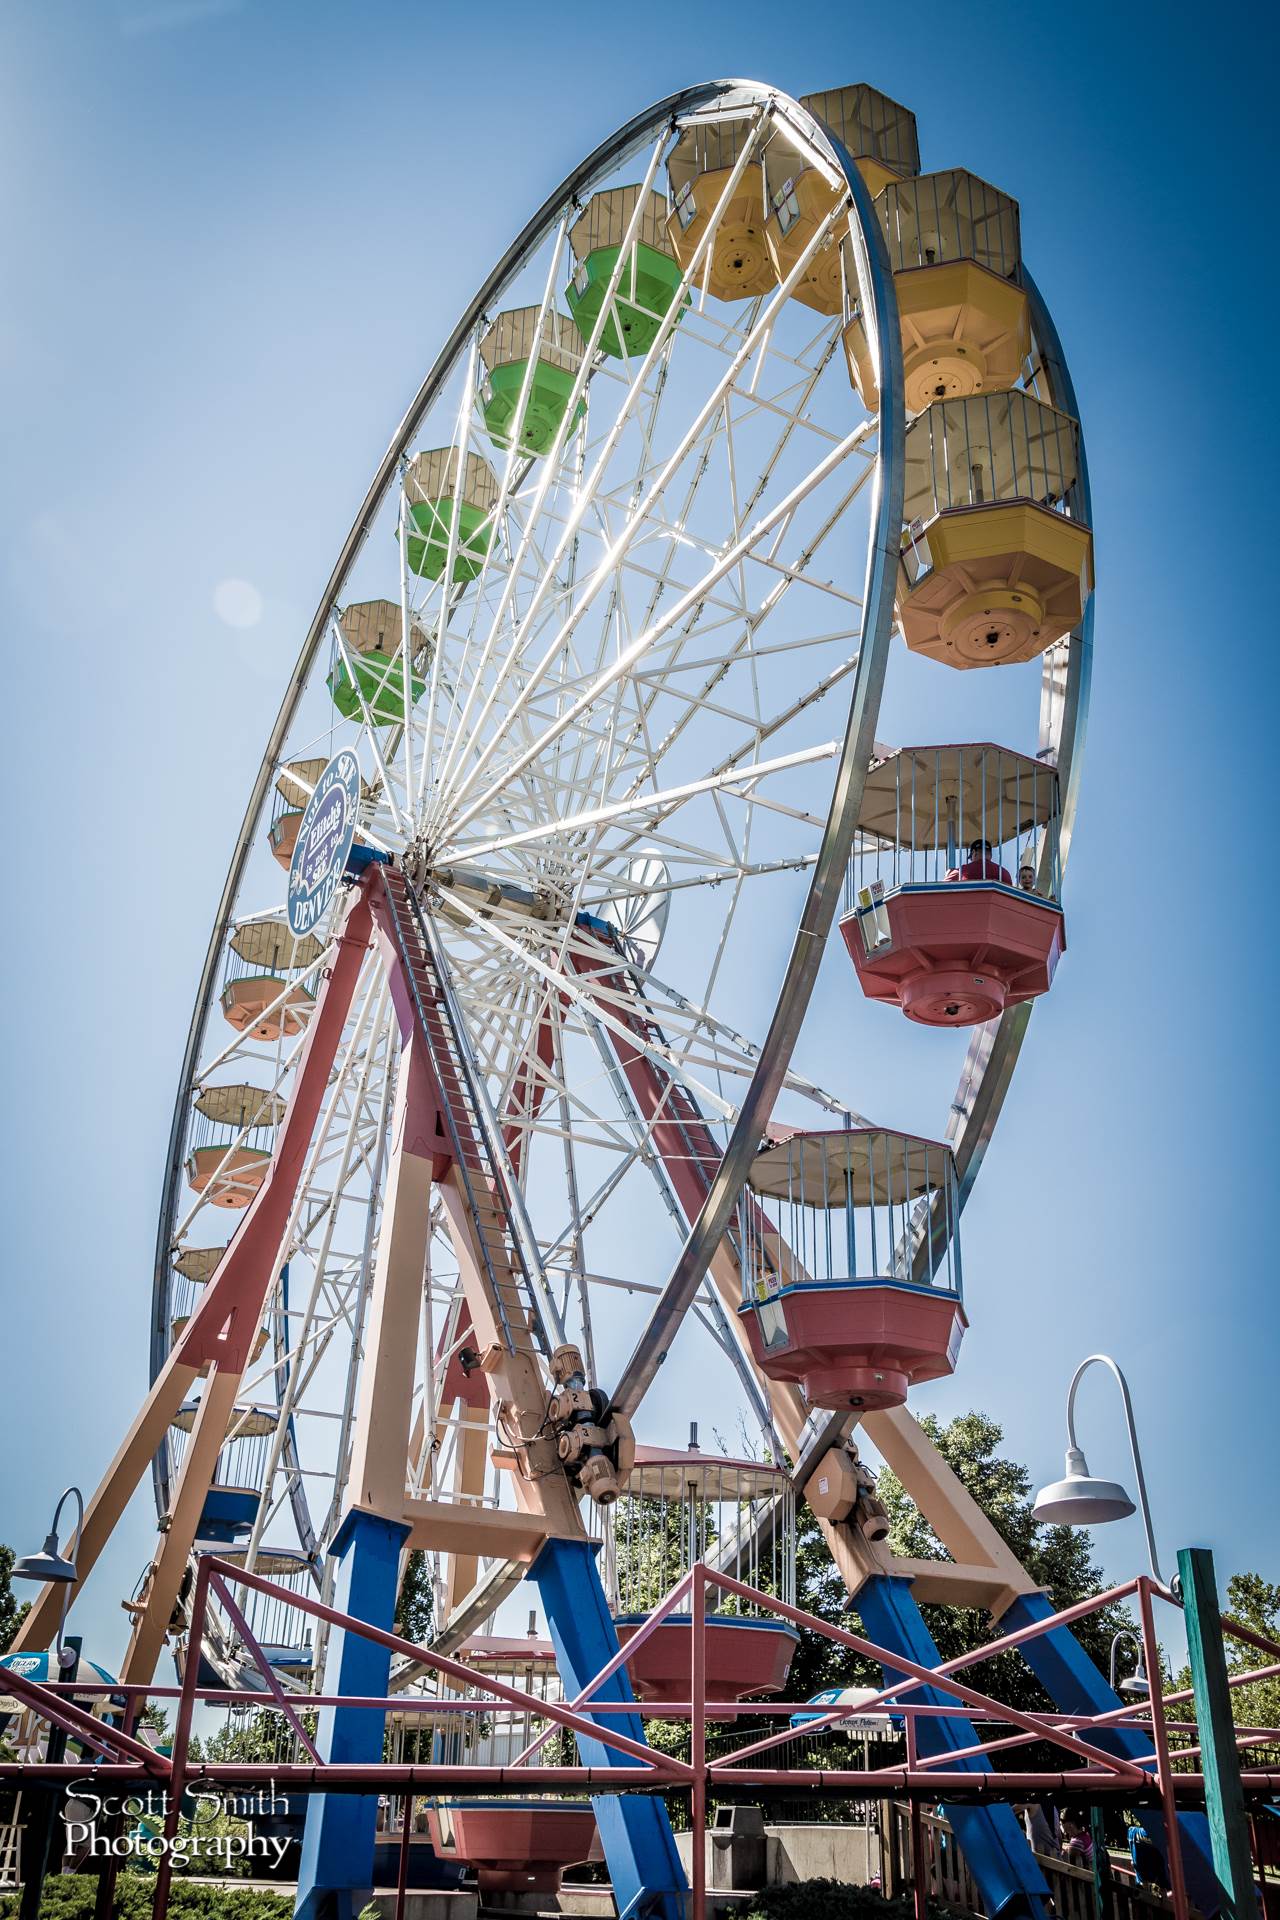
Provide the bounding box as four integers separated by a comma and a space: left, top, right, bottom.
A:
528, 1540, 687, 1920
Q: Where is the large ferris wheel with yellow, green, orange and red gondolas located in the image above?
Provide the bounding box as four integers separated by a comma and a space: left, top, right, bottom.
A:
7, 83, 1092, 1735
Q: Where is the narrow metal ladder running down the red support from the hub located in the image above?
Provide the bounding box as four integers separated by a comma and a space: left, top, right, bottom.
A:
380, 864, 560, 1357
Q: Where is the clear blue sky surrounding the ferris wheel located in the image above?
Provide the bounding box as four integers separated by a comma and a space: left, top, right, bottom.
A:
0, 0, 1280, 1659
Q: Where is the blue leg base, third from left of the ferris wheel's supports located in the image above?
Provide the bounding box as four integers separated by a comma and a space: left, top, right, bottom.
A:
854, 1574, 1050, 1920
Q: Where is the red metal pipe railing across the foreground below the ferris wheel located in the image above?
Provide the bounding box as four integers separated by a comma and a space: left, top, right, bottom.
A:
0, 1555, 1280, 1920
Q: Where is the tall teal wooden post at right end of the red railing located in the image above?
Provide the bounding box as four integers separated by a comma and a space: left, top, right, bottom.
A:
1178, 1548, 1257, 1920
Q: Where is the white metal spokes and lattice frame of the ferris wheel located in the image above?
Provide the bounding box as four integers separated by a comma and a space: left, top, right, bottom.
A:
152, 81, 1092, 1658
